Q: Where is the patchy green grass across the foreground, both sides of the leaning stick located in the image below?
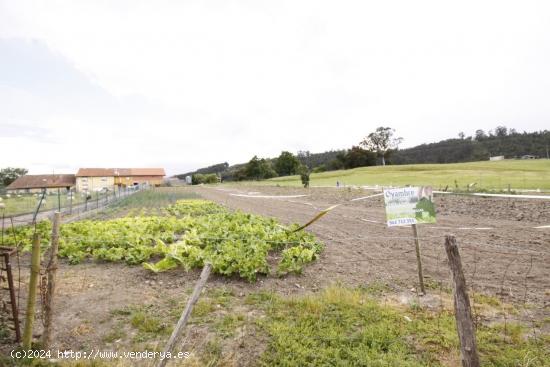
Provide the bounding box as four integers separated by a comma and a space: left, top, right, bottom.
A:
5, 283, 550, 367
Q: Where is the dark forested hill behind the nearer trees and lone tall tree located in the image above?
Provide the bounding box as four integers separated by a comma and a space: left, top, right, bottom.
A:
176, 126, 550, 181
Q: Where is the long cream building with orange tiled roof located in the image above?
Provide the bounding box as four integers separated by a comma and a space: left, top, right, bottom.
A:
76, 168, 166, 192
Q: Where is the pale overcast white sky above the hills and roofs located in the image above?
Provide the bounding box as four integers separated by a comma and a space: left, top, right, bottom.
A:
0, 0, 550, 174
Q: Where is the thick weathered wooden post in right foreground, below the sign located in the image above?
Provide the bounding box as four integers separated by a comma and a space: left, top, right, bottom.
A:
445, 236, 479, 367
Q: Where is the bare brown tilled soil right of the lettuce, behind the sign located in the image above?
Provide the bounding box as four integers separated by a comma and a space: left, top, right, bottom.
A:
194, 186, 550, 308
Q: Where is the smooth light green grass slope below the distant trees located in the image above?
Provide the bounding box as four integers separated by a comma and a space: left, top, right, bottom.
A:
263, 159, 550, 191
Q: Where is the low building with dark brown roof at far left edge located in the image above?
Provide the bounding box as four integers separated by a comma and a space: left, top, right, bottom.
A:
6, 174, 76, 194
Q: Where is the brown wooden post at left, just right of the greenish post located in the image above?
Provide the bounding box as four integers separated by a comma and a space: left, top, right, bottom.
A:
42, 212, 61, 349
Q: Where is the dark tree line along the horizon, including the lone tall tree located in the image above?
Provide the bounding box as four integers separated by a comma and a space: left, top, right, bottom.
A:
177, 126, 550, 184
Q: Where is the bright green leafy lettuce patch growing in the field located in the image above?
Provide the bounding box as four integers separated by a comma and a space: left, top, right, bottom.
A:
4, 200, 323, 281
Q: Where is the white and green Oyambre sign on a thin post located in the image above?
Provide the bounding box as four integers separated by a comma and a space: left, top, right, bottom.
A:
384, 186, 435, 227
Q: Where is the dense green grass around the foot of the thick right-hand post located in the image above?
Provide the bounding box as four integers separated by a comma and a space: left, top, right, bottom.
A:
256, 287, 550, 367
